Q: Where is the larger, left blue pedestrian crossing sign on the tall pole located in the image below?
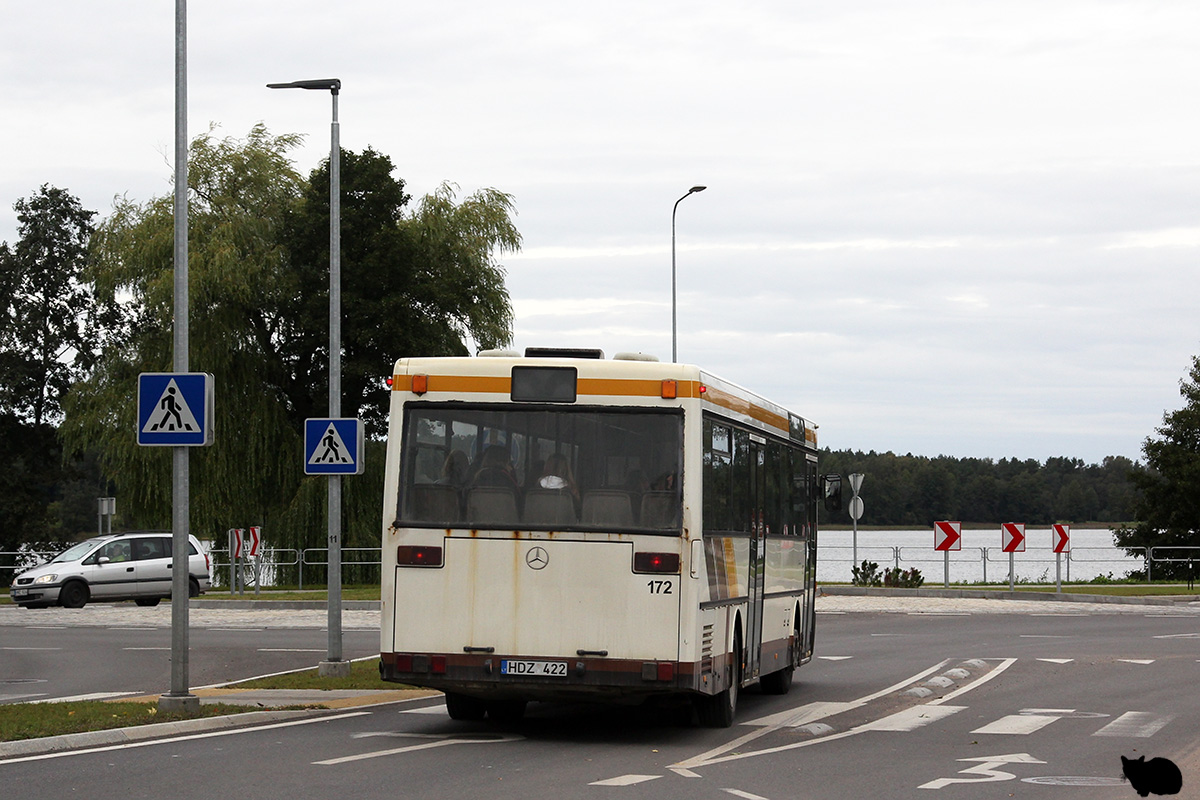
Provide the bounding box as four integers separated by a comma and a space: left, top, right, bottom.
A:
138, 372, 212, 447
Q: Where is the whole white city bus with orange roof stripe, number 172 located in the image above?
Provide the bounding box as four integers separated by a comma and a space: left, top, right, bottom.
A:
380, 349, 841, 727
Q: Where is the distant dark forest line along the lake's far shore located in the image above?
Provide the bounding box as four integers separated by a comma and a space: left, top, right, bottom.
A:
820, 450, 1142, 527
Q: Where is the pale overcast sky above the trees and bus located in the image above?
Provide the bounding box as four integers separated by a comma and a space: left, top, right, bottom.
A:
0, 0, 1200, 463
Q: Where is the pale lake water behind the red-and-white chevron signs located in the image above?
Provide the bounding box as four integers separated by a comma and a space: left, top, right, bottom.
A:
817, 525, 1142, 585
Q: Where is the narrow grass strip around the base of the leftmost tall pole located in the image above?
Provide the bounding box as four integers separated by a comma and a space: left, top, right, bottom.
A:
0, 700, 270, 741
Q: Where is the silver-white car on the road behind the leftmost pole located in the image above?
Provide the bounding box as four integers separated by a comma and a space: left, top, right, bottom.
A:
10, 531, 212, 608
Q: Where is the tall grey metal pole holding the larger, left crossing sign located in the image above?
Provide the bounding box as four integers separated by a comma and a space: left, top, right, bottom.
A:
158, 0, 200, 711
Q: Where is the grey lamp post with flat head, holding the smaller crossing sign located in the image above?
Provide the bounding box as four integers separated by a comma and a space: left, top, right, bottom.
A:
266, 78, 350, 676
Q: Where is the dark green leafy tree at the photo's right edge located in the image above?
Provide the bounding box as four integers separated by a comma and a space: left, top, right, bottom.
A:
1115, 356, 1200, 578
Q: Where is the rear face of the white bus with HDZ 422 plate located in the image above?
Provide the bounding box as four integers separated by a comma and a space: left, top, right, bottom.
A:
380, 357, 696, 718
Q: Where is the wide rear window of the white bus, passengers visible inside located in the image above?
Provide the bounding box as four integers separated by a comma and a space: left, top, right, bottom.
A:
398, 403, 683, 534
